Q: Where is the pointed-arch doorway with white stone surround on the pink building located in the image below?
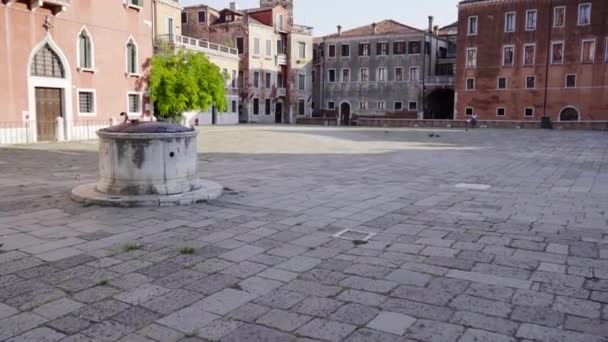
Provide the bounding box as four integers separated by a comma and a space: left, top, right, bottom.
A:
27, 35, 72, 141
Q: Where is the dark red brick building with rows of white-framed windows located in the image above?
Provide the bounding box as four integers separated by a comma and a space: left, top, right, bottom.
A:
456, 0, 608, 123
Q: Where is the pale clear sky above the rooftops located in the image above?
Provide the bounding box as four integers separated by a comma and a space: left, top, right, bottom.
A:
182, 0, 459, 36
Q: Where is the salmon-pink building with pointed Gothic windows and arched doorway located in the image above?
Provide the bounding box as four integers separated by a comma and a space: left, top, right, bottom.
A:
0, 0, 152, 144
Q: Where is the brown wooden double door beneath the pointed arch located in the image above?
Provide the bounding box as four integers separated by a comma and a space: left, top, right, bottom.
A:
36, 88, 63, 141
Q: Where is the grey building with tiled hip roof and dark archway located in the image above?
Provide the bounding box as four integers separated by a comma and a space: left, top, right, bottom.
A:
314, 17, 455, 125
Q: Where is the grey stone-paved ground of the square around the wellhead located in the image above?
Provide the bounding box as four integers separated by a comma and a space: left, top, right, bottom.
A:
0, 127, 608, 342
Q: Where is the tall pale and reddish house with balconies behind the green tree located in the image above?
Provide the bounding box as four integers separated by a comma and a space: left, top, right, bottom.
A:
182, 0, 312, 123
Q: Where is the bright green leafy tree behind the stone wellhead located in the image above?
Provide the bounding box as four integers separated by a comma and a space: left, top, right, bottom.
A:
149, 50, 228, 122
